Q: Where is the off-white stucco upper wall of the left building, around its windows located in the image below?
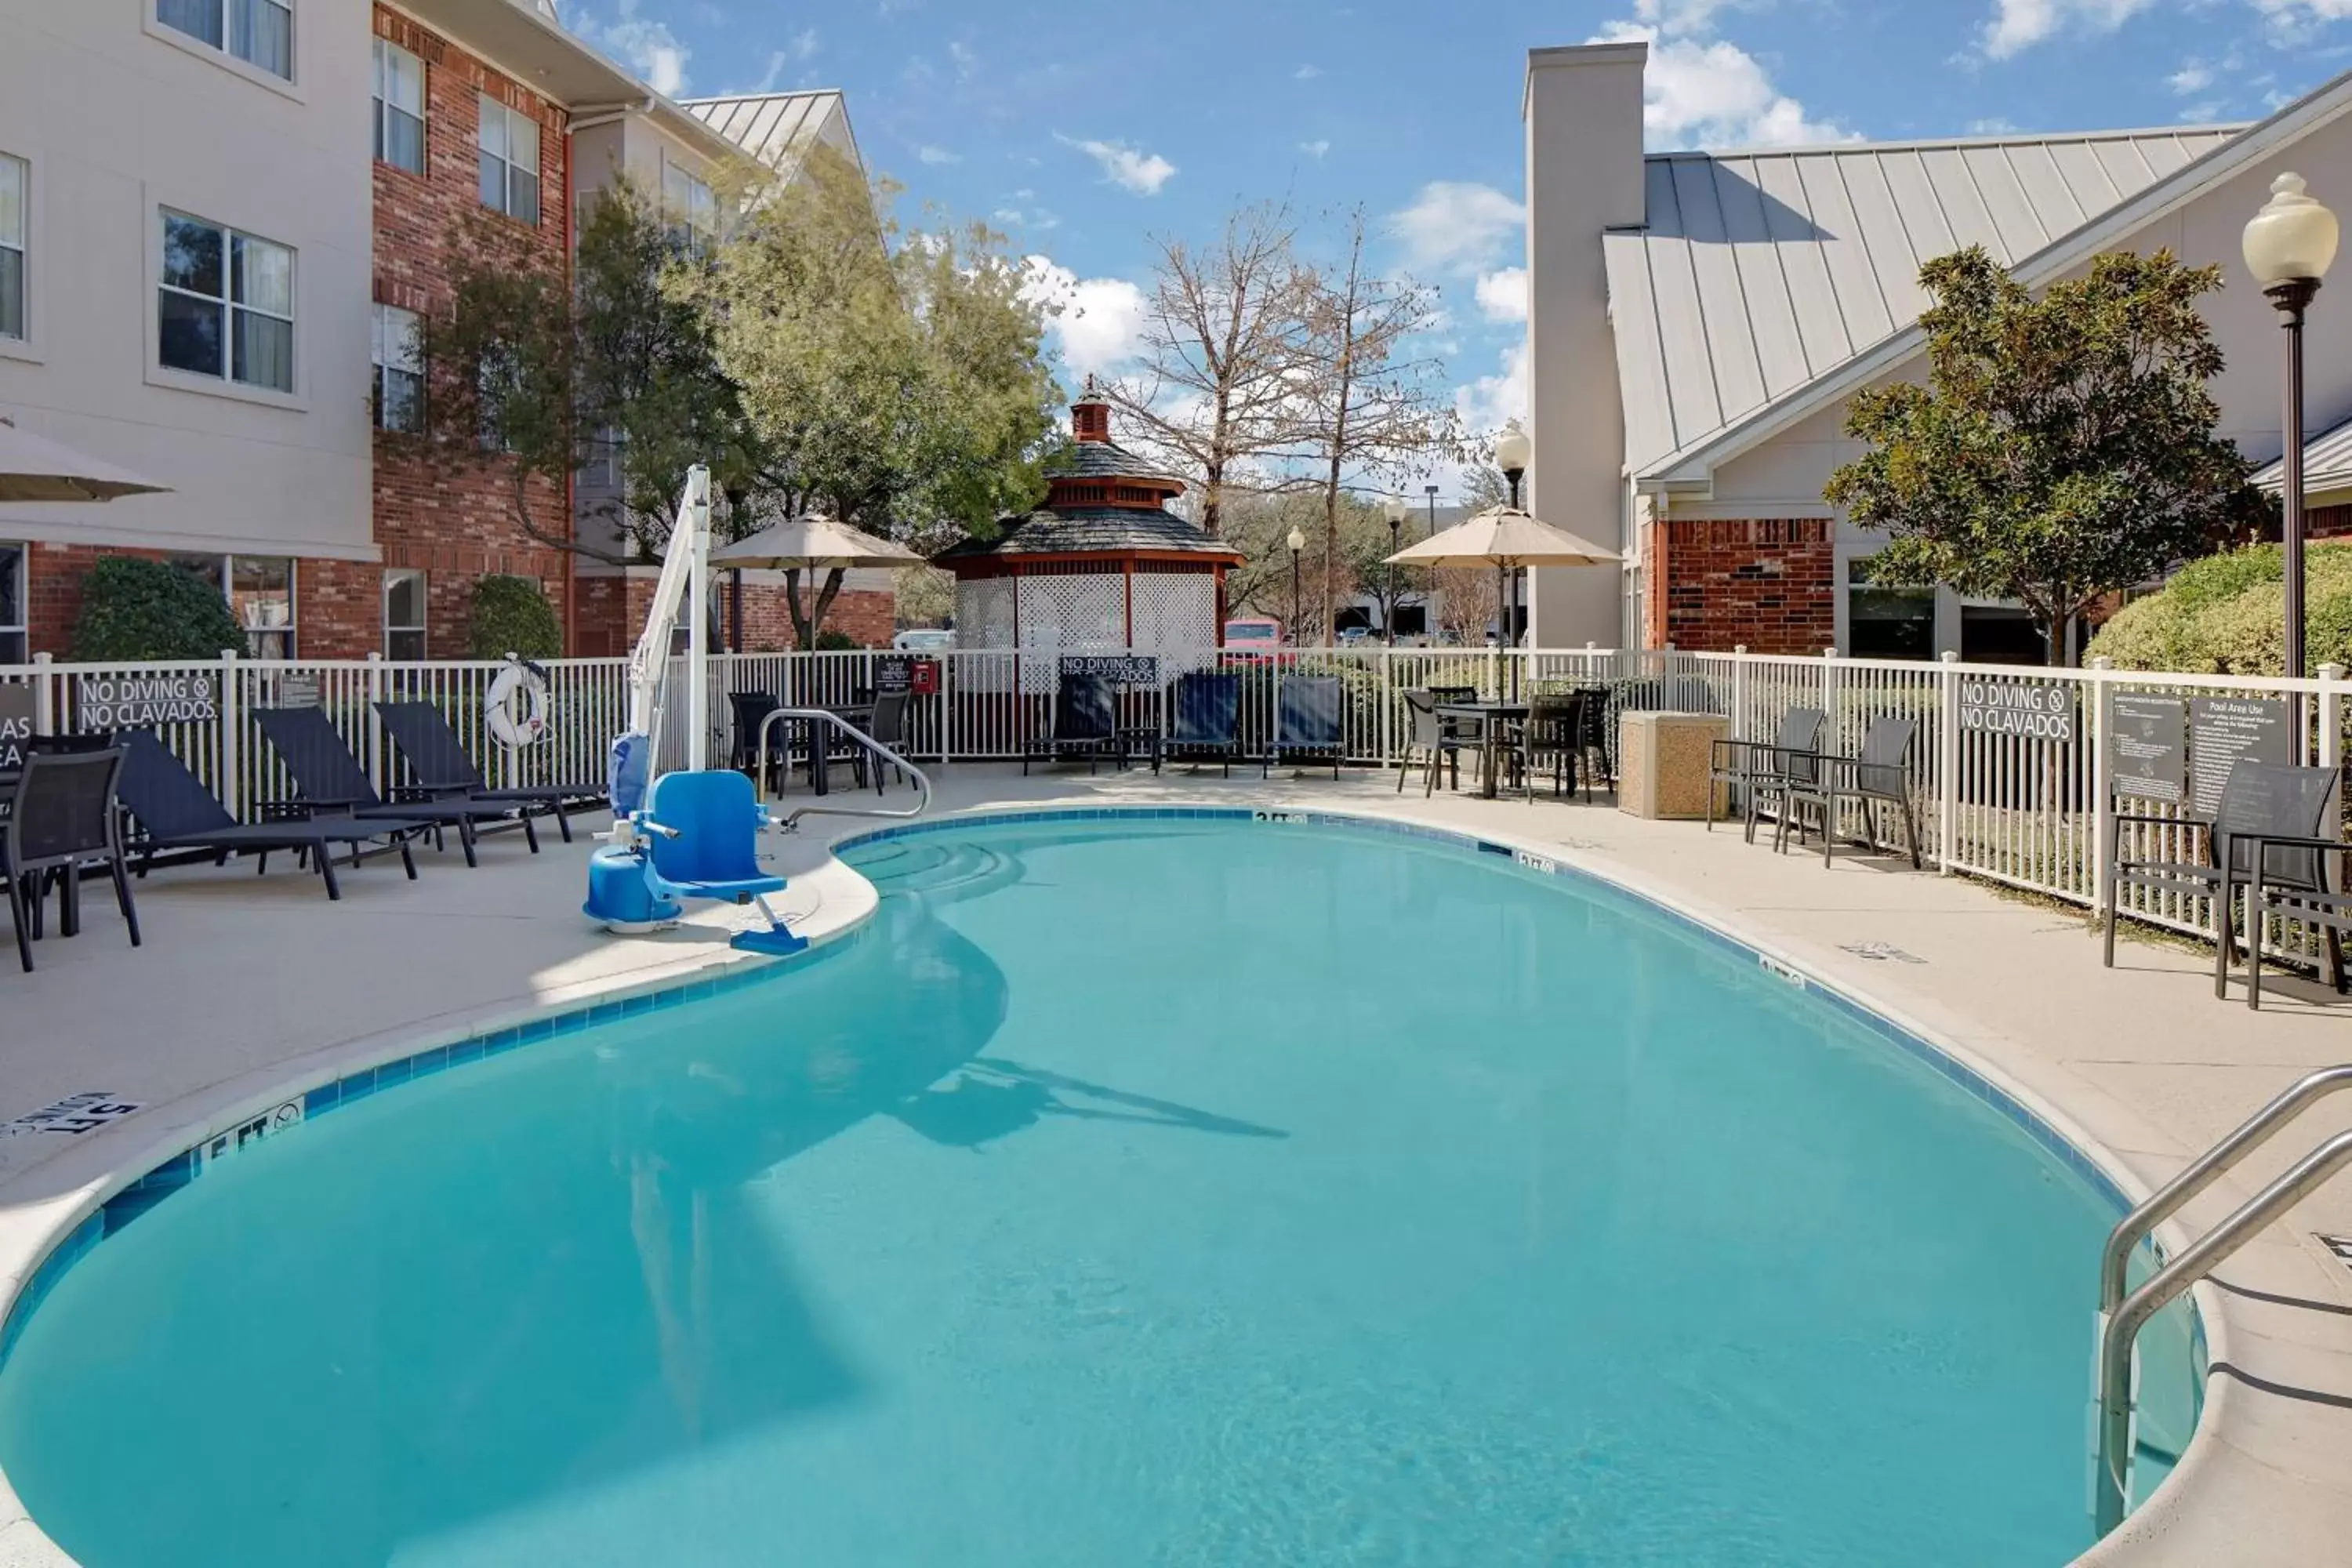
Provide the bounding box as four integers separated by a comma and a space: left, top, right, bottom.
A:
0, 0, 374, 557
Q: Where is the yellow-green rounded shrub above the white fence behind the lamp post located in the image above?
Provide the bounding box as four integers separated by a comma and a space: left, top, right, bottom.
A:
2086, 546, 2352, 675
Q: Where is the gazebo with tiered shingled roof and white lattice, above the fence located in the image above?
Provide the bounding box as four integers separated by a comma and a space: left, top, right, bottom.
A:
936, 379, 1242, 654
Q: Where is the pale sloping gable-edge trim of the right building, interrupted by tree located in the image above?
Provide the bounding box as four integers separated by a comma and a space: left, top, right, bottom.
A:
1630, 71, 2352, 489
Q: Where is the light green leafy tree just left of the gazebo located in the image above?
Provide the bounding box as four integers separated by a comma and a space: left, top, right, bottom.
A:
689, 148, 1061, 647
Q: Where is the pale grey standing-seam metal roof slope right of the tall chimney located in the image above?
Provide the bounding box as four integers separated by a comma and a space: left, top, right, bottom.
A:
1602, 125, 2244, 475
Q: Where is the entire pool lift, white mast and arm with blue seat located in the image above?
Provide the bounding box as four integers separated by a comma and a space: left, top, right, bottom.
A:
583, 463, 809, 954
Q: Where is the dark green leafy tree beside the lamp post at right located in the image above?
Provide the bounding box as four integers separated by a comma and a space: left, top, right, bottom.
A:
1825, 247, 2267, 659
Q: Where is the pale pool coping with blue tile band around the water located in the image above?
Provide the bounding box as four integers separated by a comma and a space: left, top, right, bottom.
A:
0, 801, 2234, 1568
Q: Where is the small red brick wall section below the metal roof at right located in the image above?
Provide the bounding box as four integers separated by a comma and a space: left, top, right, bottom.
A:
1644, 517, 1837, 654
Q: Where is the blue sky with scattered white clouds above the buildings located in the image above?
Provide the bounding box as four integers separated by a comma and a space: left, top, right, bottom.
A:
560, 0, 2352, 479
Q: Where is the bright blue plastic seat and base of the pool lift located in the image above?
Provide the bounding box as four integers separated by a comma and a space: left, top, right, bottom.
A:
588, 769, 809, 954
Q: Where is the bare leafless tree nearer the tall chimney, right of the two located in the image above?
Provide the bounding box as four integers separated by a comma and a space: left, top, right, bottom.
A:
1298, 207, 1458, 637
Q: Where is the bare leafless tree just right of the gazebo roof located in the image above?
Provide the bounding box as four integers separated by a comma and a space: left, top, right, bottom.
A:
1105, 202, 1312, 539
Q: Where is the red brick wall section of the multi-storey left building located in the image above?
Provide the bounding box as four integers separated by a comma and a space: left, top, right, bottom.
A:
369, 7, 572, 659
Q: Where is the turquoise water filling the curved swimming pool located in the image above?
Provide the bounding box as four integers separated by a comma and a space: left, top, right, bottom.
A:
0, 822, 2183, 1568
